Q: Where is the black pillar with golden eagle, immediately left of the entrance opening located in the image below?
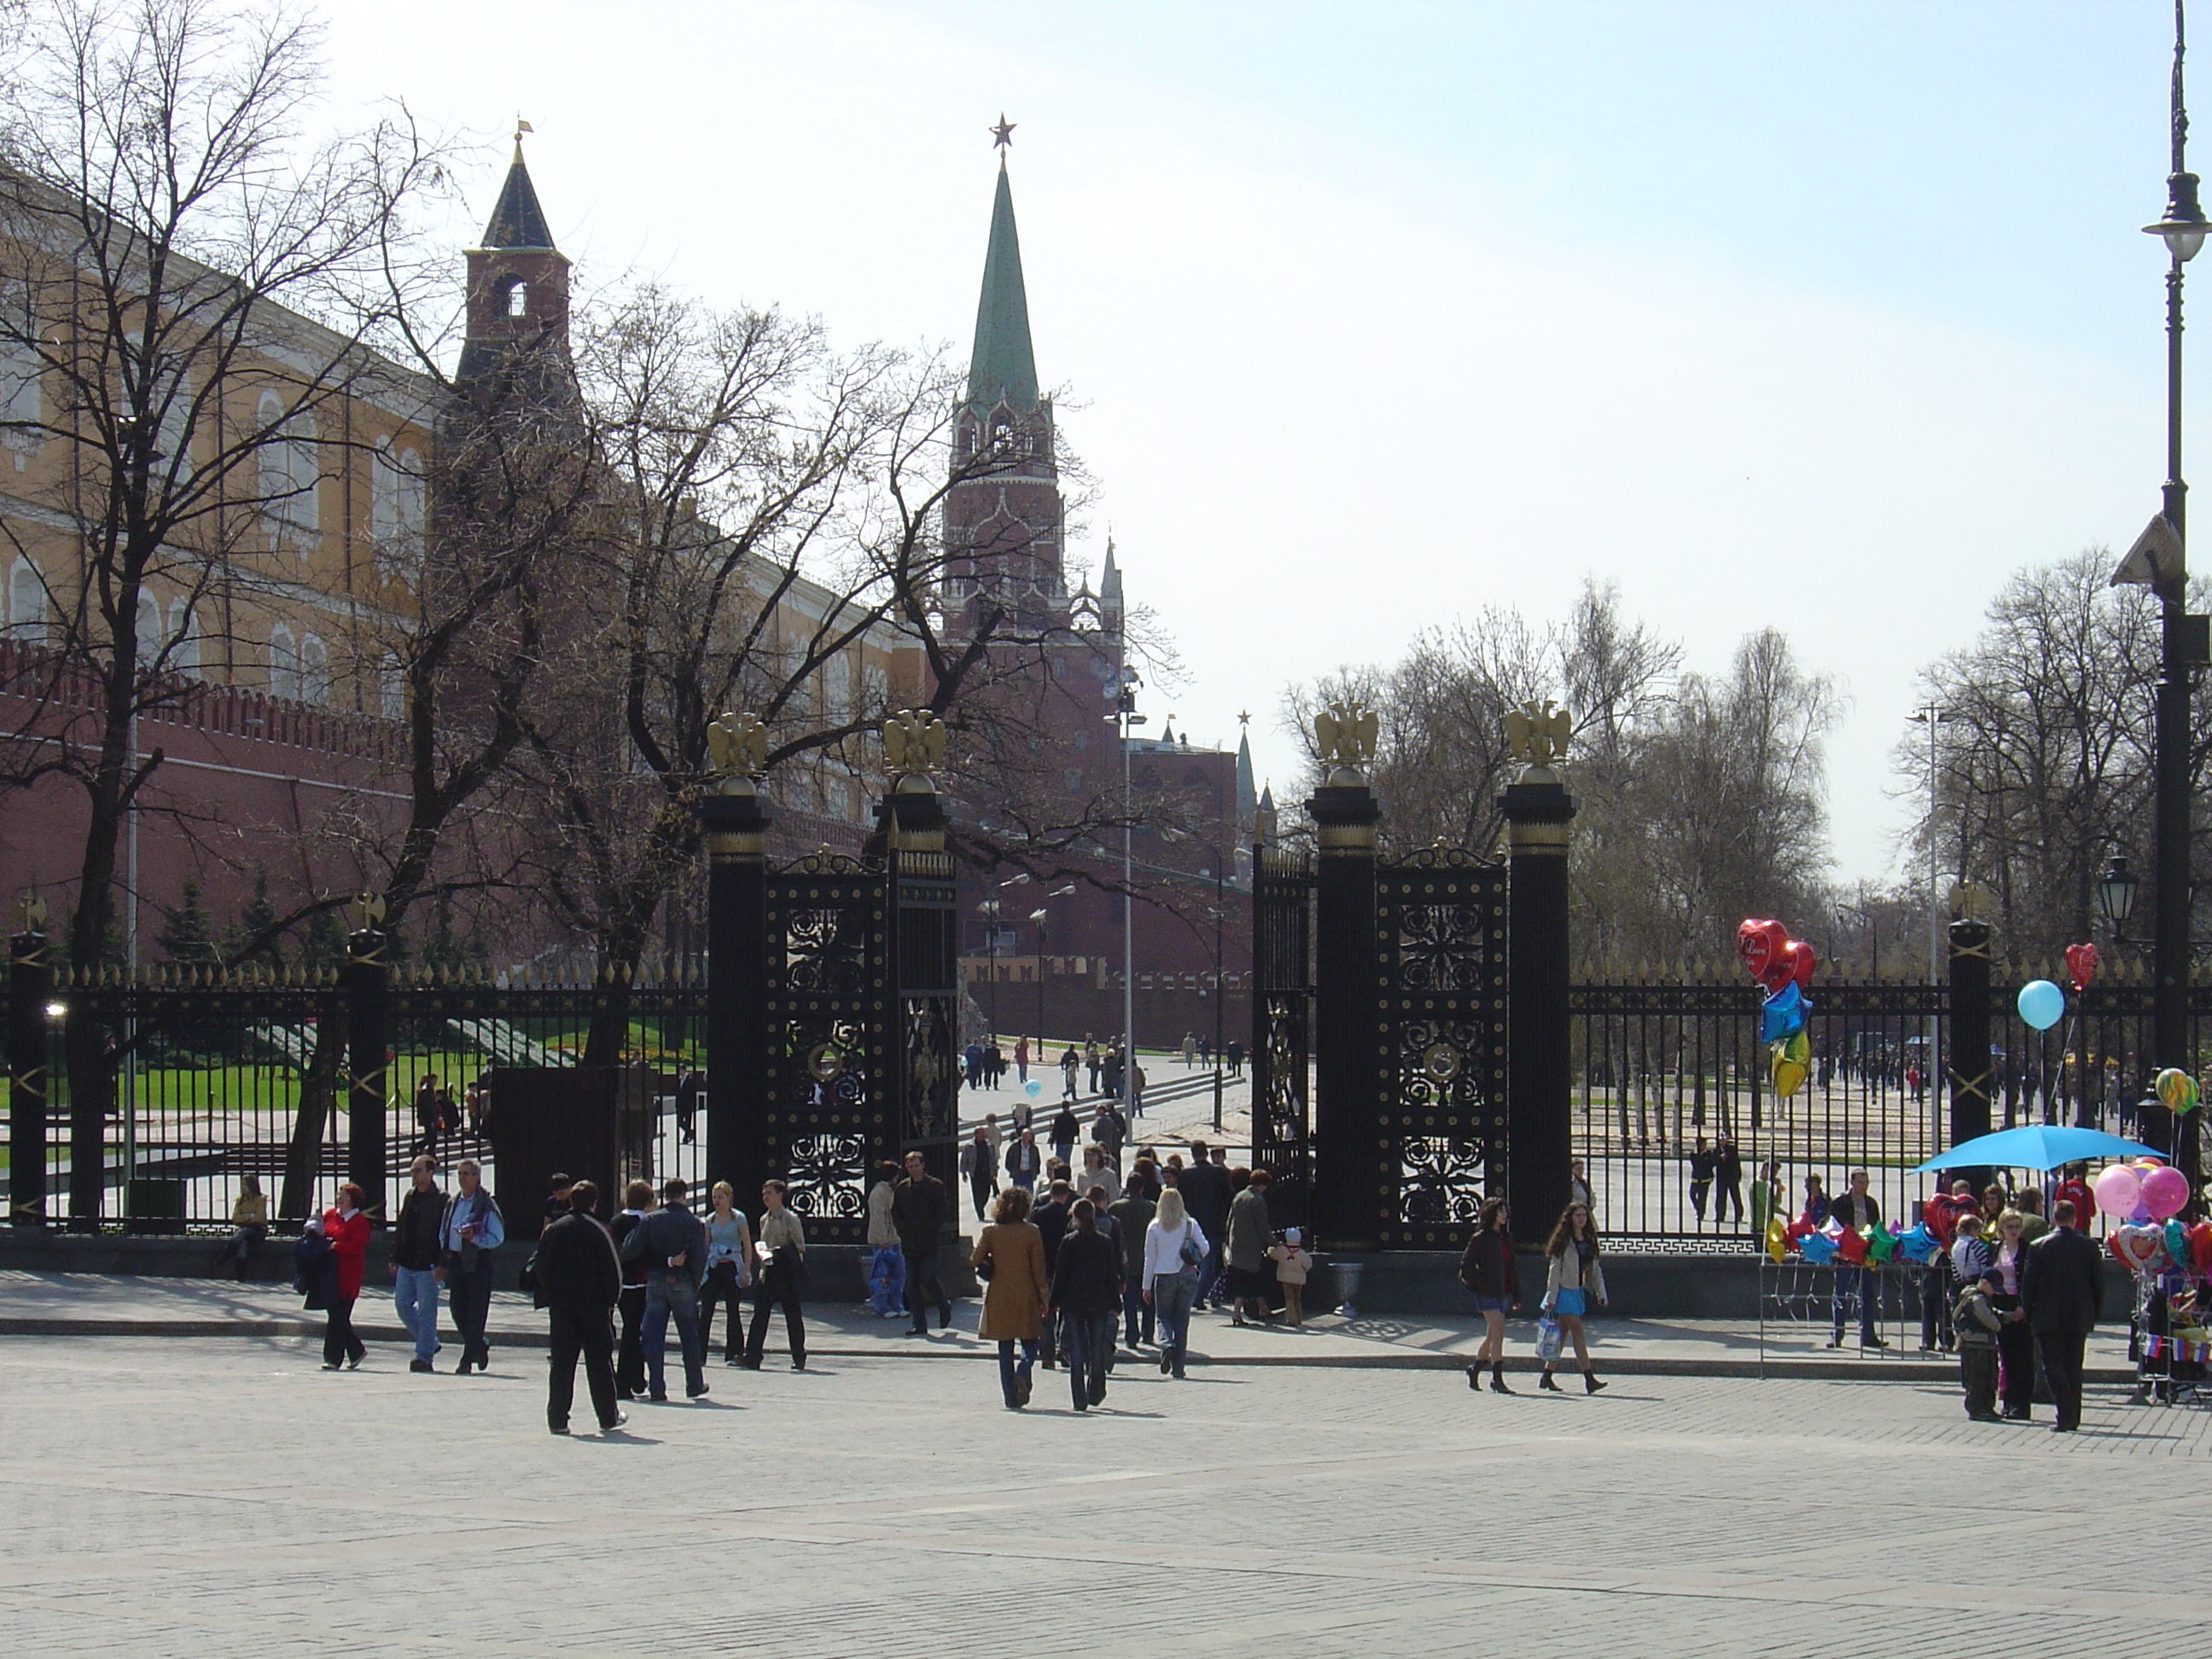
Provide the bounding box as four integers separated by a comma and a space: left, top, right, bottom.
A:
871, 710, 960, 1210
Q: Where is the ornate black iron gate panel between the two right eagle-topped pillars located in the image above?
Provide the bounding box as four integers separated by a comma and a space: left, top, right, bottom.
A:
1374, 847, 1506, 1249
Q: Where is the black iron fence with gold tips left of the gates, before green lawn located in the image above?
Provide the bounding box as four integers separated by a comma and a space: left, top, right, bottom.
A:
7, 969, 706, 1232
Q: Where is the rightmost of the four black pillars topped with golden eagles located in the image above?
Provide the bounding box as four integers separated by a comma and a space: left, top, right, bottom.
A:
1498, 738, 1575, 1245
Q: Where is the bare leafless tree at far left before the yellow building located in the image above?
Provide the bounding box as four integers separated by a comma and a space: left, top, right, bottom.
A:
0, 0, 462, 1210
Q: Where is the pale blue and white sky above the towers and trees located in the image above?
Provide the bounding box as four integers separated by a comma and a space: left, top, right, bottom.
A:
329, 0, 2212, 898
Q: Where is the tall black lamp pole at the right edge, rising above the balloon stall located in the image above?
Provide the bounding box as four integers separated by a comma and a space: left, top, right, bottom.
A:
2112, 0, 2212, 1185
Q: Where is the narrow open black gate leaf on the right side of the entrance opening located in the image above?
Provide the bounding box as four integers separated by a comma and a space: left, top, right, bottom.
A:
1252, 847, 1314, 1170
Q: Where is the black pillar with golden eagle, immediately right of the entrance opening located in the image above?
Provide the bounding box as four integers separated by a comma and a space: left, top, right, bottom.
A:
1305, 752, 1385, 1249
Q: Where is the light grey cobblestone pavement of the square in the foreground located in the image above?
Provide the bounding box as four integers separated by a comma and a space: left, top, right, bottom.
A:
0, 1336, 2212, 1659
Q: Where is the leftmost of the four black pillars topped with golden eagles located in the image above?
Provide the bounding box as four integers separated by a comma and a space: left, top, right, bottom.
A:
699, 714, 778, 1208
